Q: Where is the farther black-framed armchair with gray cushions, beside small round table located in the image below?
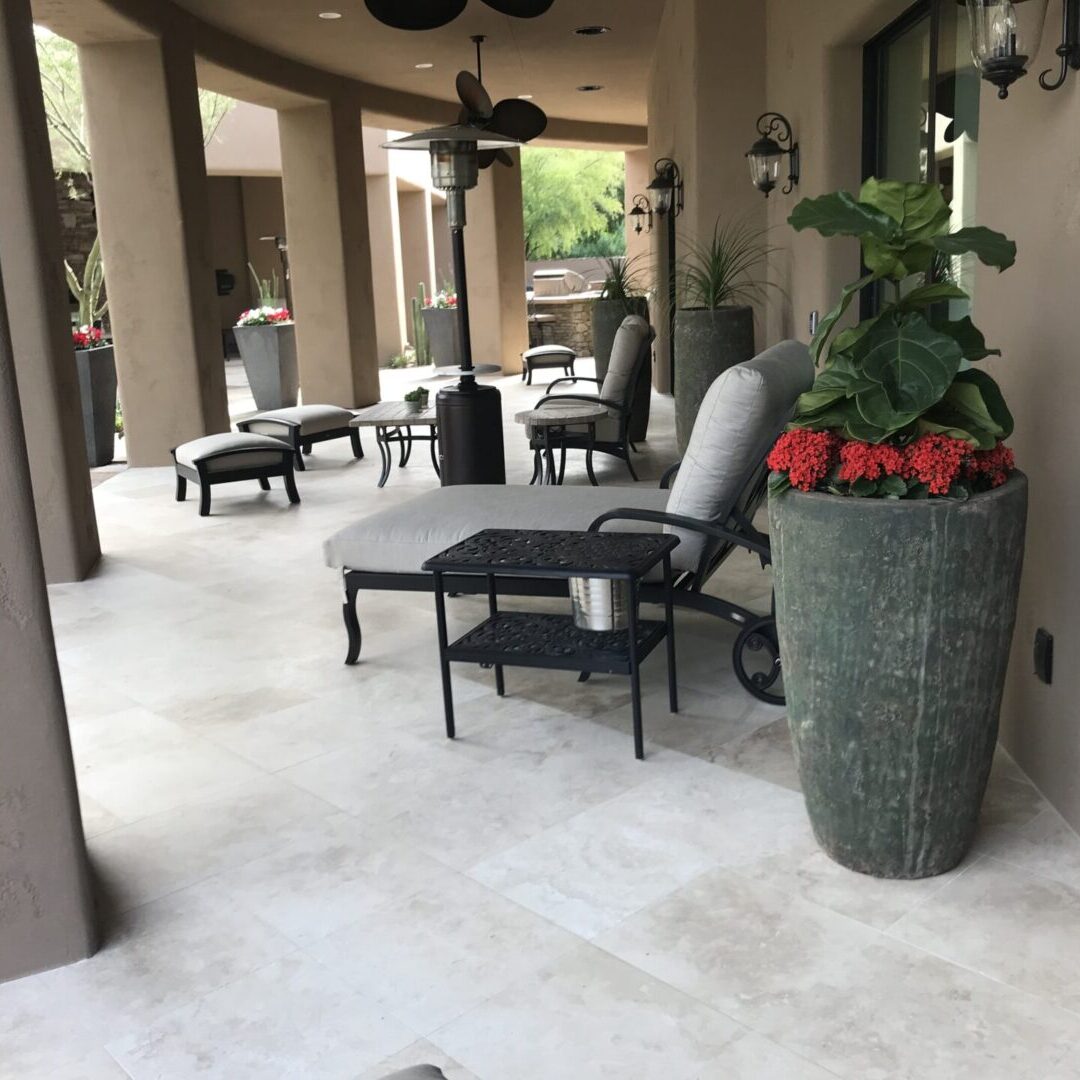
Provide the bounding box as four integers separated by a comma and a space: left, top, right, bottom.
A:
526, 315, 657, 483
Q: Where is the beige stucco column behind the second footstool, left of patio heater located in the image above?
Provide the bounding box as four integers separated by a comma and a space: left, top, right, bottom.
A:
278, 100, 379, 408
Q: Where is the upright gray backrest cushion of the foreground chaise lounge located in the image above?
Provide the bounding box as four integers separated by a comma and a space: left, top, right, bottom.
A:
667, 341, 814, 563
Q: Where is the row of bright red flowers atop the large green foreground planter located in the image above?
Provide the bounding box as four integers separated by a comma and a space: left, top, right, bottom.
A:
768, 428, 1015, 495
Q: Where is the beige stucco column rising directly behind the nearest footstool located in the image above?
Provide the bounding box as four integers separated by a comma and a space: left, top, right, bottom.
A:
79, 32, 229, 465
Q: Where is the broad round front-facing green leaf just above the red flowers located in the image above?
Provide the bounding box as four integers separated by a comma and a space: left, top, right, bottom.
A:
852, 312, 963, 416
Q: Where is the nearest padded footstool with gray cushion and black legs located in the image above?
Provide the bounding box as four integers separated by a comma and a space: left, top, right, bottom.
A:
173, 432, 300, 517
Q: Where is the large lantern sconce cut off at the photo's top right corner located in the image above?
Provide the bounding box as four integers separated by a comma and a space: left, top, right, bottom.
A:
966, 0, 1080, 98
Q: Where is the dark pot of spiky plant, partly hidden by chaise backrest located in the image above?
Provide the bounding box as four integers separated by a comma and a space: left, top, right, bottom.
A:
674, 307, 754, 456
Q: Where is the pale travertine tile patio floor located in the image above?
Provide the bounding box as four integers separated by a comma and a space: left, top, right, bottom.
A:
8, 365, 1080, 1080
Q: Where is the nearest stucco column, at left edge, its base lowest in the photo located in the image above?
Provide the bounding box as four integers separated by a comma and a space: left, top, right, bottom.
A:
0, 263, 96, 981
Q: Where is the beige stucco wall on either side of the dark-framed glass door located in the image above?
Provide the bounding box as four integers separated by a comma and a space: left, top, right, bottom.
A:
767, 0, 1080, 826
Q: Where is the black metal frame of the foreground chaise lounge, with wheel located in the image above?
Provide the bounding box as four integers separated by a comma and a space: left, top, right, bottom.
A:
342, 451, 784, 705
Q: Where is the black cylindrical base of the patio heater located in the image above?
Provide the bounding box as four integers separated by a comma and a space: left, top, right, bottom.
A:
435, 378, 507, 487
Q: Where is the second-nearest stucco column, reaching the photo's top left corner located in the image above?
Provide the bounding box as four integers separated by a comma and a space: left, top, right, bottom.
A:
0, 0, 100, 591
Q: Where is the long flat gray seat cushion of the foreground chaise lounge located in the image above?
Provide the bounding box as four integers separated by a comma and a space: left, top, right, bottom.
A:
323, 485, 681, 573
